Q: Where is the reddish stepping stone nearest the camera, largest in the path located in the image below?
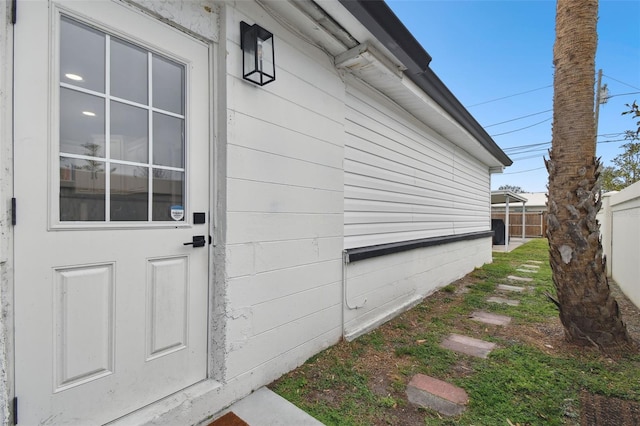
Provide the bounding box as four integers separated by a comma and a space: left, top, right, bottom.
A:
407, 374, 469, 416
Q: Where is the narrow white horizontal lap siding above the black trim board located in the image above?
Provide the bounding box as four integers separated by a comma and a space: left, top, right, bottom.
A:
344, 86, 490, 248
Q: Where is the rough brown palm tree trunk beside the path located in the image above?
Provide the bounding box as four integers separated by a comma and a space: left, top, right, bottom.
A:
546, 0, 631, 350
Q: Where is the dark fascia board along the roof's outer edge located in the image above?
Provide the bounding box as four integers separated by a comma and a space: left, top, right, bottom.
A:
338, 0, 513, 166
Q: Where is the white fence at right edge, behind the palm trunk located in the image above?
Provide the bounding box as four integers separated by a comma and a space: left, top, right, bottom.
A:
598, 182, 640, 306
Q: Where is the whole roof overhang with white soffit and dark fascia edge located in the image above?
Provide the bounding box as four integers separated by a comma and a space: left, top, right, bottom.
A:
258, 0, 512, 173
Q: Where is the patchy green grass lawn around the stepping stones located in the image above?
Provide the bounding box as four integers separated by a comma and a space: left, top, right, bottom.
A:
270, 239, 640, 426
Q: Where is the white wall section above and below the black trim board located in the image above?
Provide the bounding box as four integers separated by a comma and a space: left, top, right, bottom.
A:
345, 82, 491, 338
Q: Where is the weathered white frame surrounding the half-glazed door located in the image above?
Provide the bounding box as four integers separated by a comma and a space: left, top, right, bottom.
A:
0, 0, 230, 424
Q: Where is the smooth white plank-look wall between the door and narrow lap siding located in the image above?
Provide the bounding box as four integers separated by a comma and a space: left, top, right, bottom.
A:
225, 2, 344, 384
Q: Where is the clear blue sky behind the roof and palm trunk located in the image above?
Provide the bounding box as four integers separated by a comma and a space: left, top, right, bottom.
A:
386, 0, 640, 192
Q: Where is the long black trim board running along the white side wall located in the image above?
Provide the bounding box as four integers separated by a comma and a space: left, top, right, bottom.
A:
344, 231, 493, 263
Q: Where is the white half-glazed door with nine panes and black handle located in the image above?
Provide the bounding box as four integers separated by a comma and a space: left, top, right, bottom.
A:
14, 0, 210, 425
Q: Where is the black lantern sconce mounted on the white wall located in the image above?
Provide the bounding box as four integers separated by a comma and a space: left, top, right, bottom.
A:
240, 22, 276, 86
